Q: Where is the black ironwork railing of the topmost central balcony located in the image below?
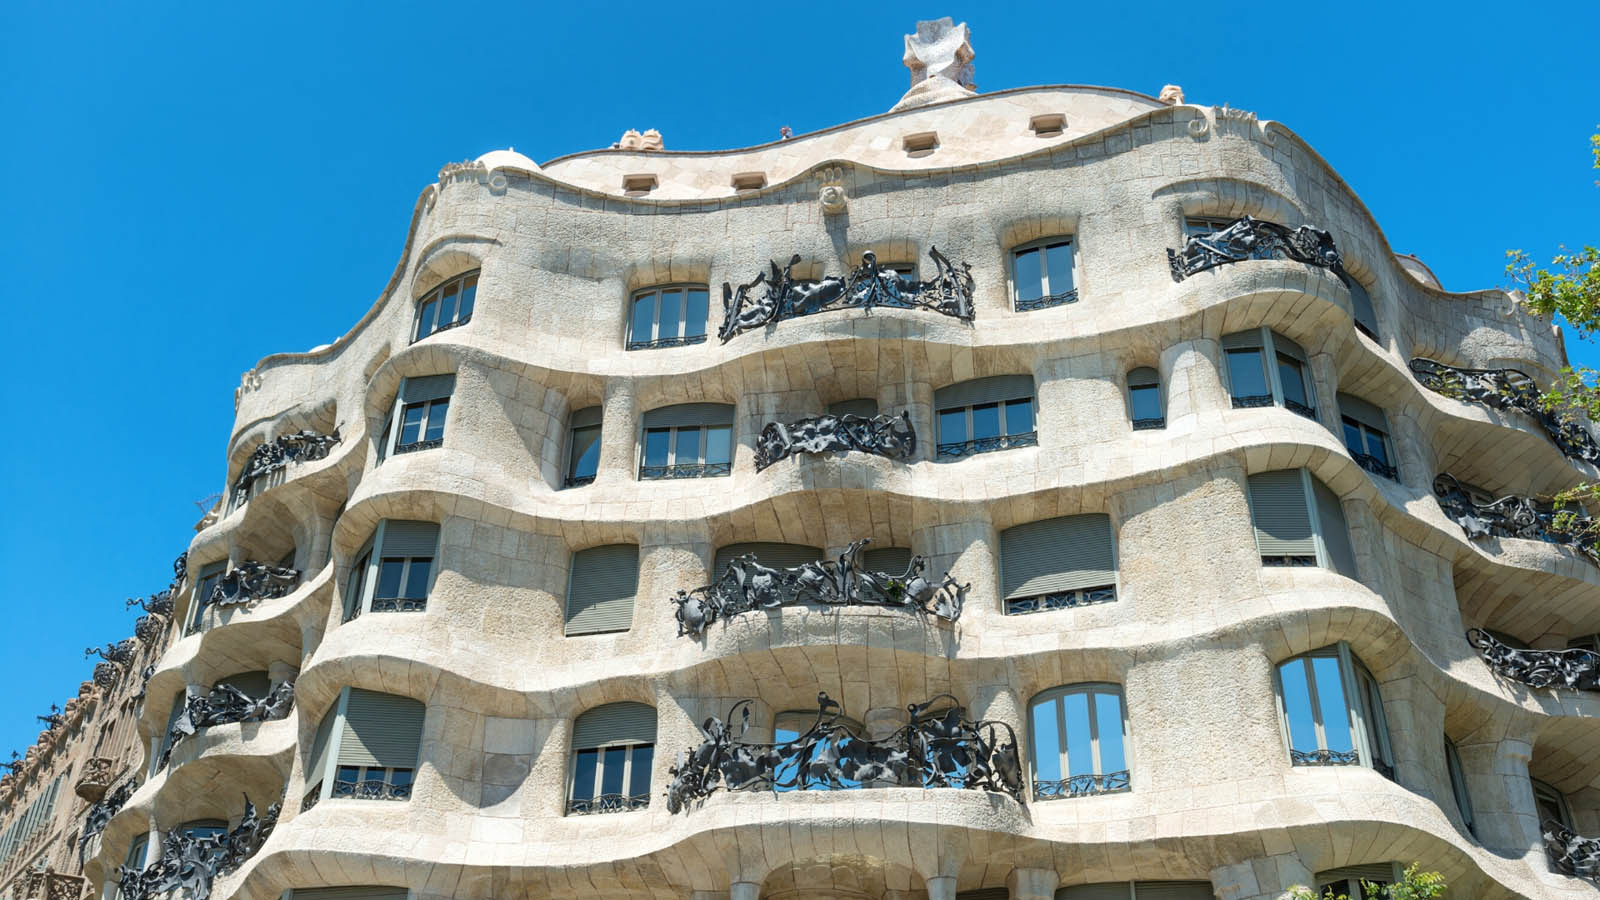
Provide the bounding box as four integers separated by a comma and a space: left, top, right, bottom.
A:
717, 247, 974, 343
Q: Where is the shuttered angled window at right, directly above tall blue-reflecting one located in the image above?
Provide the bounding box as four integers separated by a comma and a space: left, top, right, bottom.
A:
1248, 469, 1355, 578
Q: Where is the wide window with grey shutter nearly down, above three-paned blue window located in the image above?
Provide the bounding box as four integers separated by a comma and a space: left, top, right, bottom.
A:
1000, 512, 1117, 615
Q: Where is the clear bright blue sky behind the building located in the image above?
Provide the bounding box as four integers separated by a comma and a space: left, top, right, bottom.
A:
0, 0, 1600, 757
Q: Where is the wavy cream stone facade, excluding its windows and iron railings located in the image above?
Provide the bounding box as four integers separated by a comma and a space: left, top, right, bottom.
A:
86, 19, 1600, 900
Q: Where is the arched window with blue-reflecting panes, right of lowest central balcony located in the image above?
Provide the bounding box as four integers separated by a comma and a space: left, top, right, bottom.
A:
1027, 684, 1130, 801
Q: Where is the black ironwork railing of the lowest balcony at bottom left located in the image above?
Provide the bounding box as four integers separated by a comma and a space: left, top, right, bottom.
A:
117, 796, 283, 900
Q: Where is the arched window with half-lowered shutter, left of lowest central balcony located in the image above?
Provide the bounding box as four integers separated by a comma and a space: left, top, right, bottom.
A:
566, 703, 656, 815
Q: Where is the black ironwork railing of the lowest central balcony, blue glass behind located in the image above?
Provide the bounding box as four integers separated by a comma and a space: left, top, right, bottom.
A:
667, 693, 1022, 814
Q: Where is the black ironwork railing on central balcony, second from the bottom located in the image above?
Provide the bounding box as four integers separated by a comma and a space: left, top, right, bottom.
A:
672, 538, 971, 637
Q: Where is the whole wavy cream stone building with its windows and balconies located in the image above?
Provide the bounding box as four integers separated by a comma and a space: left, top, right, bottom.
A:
86, 21, 1600, 900
